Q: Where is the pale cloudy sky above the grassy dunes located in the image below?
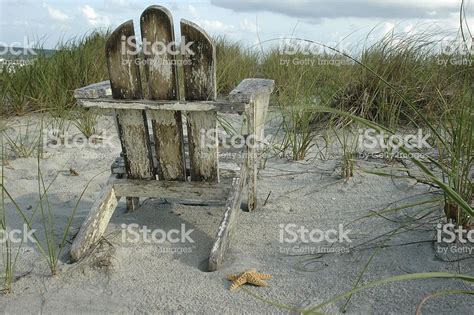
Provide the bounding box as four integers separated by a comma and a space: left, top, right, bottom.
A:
0, 0, 474, 48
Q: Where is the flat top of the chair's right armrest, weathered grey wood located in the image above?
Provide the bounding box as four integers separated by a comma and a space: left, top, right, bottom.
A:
229, 78, 275, 103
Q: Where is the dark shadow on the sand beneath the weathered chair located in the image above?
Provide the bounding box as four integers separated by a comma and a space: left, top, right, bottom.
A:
111, 198, 224, 272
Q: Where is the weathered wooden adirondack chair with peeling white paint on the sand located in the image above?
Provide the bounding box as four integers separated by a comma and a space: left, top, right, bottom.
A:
70, 6, 273, 271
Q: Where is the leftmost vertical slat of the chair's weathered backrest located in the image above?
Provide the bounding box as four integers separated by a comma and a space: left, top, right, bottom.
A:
105, 20, 154, 179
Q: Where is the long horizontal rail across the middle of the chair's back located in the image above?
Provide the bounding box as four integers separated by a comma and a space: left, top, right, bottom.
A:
77, 98, 246, 114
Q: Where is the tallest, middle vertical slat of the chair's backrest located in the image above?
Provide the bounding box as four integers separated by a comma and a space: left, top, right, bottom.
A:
140, 5, 186, 181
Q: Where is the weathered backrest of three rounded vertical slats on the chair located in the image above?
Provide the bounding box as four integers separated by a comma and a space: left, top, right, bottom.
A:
106, 6, 219, 181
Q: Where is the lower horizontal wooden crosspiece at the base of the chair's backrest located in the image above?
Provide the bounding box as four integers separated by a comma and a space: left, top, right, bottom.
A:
114, 179, 229, 203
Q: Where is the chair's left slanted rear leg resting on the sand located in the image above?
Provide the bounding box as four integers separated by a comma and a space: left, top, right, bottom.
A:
70, 175, 120, 261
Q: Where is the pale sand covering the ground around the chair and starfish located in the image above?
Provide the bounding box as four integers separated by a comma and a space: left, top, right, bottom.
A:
0, 116, 474, 314
